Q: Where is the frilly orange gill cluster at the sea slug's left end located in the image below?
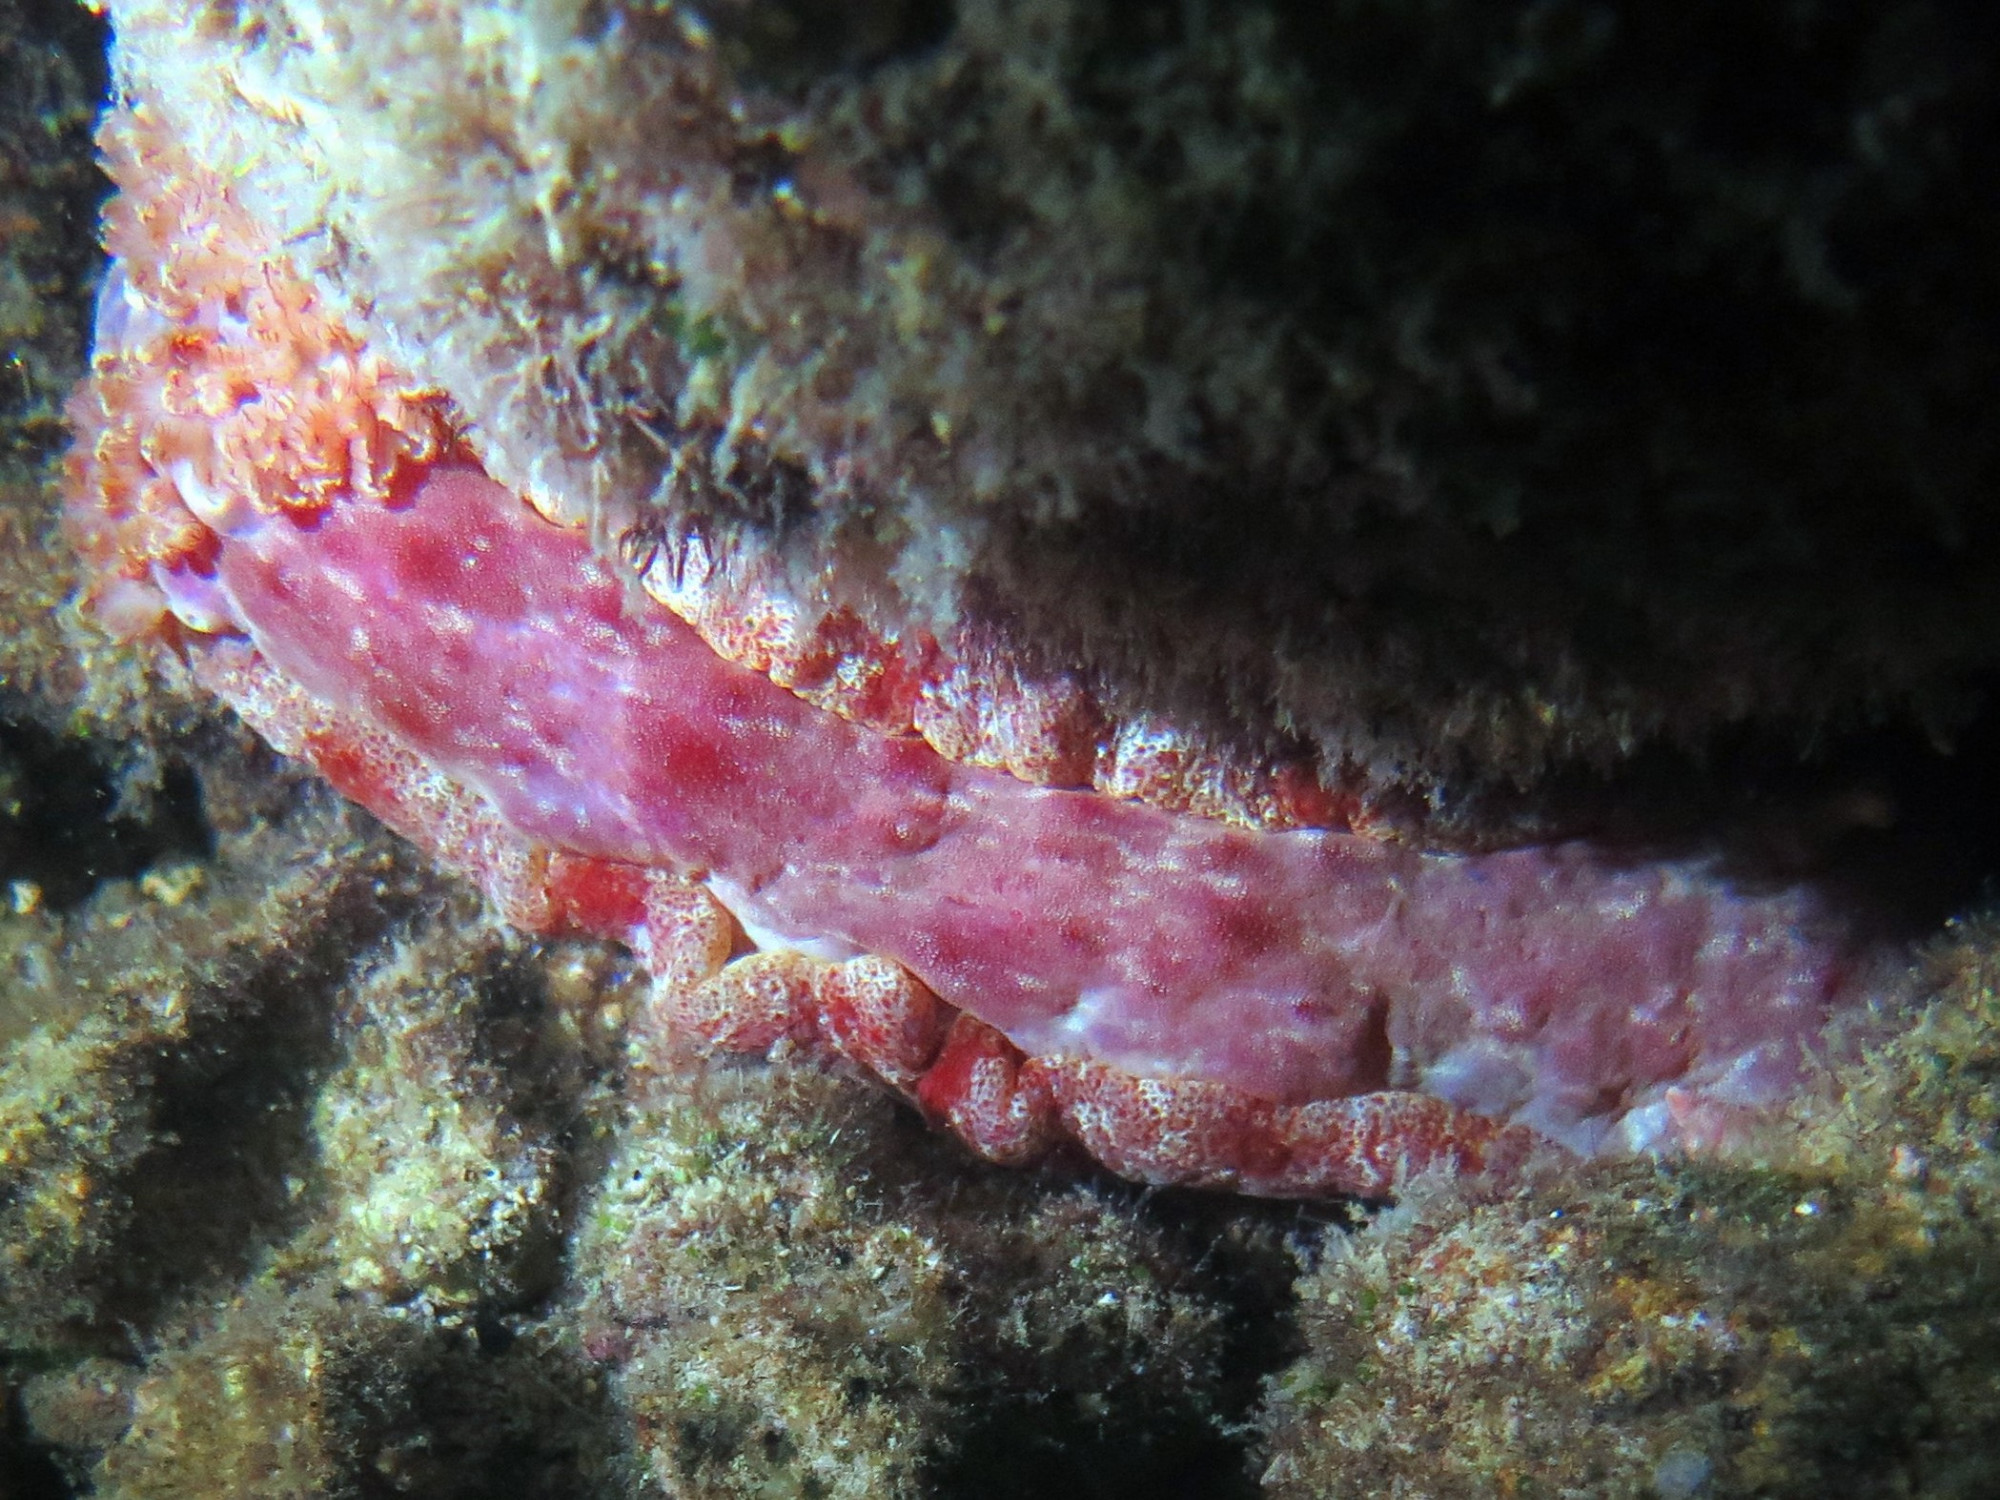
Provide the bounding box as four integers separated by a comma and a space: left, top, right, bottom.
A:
70, 106, 458, 628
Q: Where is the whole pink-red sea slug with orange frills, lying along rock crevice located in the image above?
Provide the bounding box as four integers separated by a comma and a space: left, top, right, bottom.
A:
70, 112, 1868, 1196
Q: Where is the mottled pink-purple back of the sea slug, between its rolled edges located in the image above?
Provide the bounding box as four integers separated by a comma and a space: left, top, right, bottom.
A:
184, 468, 1858, 1150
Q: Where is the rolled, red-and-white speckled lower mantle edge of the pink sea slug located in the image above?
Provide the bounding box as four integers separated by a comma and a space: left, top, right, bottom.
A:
202, 624, 1526, 1196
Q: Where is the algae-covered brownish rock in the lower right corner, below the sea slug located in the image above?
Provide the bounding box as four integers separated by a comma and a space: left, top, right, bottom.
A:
1266, 924, 2000, 1496
